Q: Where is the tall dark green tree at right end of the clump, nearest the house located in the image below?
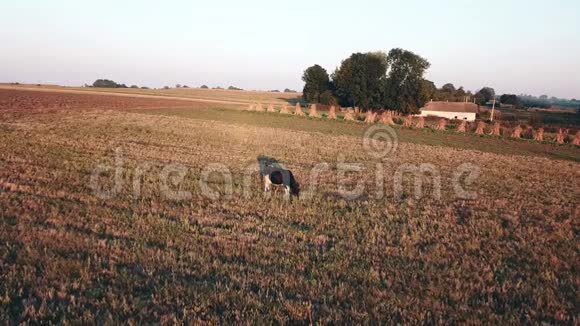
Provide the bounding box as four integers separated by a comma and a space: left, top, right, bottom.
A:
383, 49, 433, 113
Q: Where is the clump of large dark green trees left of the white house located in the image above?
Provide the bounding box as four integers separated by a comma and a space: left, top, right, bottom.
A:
302, 49, 434, 113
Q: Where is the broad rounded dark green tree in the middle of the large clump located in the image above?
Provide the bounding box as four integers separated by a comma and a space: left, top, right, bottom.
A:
333, 52, 388, 109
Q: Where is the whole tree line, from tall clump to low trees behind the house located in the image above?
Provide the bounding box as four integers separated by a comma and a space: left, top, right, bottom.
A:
302, 48, 580, 114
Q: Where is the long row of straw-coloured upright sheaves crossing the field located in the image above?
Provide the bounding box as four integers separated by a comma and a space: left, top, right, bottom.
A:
248, 103, 580, 145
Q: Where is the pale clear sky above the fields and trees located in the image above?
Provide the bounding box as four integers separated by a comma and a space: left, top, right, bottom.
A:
0, 0, 580, 98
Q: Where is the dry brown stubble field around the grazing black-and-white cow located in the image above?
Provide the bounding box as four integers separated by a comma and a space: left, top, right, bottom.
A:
0, 94, 580, 324
